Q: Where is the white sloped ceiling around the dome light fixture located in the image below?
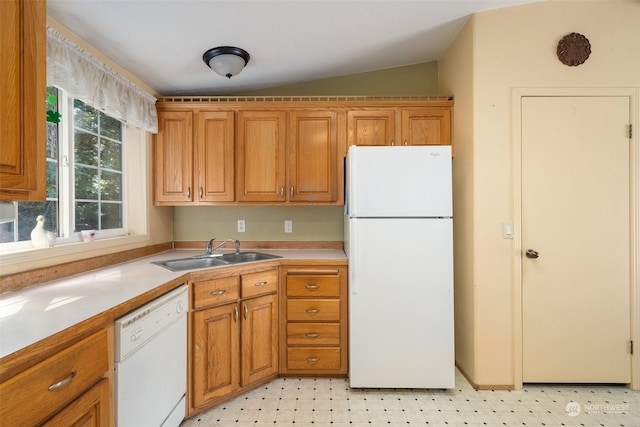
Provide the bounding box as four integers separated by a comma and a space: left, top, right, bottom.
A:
47, 0, 540, 96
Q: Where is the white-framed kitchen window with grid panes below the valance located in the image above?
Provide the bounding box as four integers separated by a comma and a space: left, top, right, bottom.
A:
0, 87, 138, 247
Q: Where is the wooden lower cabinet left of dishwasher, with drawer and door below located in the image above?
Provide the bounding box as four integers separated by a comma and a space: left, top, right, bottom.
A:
0, 326, 113, 427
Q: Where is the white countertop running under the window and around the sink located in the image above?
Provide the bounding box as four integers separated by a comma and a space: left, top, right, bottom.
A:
0, 249, 346, 358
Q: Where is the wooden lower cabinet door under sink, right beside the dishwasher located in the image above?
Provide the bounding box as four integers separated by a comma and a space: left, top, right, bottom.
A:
191, 303, 240, 408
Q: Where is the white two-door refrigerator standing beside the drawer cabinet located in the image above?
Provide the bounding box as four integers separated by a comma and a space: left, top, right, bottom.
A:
344, 146, 455, 388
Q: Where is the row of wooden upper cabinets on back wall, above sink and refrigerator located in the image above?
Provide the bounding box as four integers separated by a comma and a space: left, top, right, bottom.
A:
155, 100, 453, 206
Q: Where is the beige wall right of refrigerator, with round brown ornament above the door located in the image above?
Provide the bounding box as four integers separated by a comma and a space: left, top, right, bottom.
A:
440, 1, 640, 385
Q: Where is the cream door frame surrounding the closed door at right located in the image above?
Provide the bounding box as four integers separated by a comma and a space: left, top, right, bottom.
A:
511, 88, 640, 390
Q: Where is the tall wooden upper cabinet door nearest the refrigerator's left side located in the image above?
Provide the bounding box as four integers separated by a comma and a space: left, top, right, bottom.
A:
287, 111, 338, 202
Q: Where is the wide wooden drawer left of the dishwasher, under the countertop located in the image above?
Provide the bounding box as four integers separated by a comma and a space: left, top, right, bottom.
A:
0, 329, 109, 426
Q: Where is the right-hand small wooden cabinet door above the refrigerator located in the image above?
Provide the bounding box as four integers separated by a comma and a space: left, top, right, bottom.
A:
402, 108, 451, 145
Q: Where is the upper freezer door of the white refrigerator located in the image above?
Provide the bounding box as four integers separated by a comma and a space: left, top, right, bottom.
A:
346, 146, 453, 218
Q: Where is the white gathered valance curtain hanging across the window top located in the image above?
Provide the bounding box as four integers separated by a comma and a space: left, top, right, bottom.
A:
47, 27, 158, 133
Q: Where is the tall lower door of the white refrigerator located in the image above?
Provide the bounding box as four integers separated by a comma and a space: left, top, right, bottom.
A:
348, 219, 455, 388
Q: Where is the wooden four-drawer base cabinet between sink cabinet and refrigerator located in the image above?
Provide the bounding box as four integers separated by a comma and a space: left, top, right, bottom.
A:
280, 265, 348, 376
